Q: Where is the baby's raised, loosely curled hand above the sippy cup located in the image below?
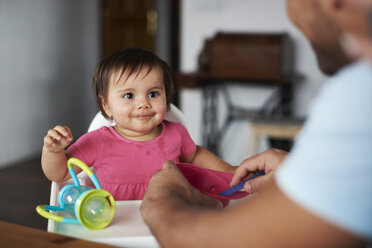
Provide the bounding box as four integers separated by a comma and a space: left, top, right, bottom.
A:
44, 125, 74, 153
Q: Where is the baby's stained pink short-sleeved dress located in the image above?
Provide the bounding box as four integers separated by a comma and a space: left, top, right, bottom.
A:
68, 120, 196, 200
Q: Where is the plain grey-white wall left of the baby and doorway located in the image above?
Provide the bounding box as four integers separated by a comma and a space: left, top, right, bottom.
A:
0, 0, 100, 167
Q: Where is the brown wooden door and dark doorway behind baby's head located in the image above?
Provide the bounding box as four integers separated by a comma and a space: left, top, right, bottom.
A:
101, 0, 181, 101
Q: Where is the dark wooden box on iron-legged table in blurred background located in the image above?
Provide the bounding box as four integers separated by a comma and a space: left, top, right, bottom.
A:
176, 33, 297, 155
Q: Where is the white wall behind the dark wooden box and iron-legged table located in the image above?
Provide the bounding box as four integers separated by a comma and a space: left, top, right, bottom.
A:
181, 0, 326, 164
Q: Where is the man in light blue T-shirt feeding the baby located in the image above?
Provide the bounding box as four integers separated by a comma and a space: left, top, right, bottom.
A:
142, 0, 372, 247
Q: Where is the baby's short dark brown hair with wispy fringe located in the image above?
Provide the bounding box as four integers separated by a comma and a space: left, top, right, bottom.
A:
93, 48, 174, 118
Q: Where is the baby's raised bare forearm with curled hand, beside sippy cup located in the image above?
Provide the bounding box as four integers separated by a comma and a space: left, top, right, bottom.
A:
41, 125, 73, 182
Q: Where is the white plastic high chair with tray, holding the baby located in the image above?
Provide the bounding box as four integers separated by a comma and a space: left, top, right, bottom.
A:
48, 104, 188, 247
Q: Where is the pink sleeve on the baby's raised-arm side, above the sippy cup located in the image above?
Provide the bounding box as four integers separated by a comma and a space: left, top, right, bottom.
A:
67, 130, 103, 167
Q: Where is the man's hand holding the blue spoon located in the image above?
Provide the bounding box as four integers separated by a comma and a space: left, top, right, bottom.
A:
230, 148, 288, 193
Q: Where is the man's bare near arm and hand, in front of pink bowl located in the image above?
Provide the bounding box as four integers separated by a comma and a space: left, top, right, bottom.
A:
141, 162, 363, 247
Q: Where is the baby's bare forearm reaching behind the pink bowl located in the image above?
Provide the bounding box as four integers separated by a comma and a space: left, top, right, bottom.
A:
180, 146, 237, 173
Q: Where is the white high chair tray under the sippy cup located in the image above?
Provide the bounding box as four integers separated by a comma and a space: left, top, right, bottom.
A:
48, 201, 160, 248
